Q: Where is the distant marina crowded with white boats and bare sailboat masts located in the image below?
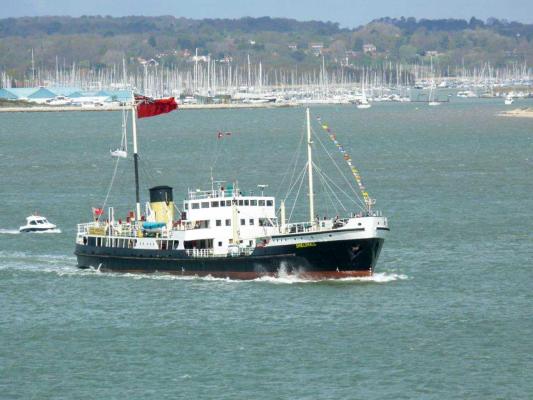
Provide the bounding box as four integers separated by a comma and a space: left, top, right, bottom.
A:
0, 56, 533, 111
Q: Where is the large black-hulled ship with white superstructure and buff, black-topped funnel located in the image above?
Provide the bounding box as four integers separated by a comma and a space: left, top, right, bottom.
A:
75, 100, 389, 279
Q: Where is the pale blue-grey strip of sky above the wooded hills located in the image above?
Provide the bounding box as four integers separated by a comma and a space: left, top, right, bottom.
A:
0, 0, 533, 27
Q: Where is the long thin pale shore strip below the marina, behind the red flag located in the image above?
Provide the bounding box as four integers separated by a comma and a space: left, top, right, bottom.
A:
0, 103, 296, 112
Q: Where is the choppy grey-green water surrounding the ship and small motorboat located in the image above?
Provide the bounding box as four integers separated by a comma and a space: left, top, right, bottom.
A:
0, 101, 533, 399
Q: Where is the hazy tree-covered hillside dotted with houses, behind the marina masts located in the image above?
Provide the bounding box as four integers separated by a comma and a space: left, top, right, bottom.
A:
0, 16, 533, 77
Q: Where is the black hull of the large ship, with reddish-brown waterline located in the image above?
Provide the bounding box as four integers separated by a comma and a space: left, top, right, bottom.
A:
75, 238, 383, 279
